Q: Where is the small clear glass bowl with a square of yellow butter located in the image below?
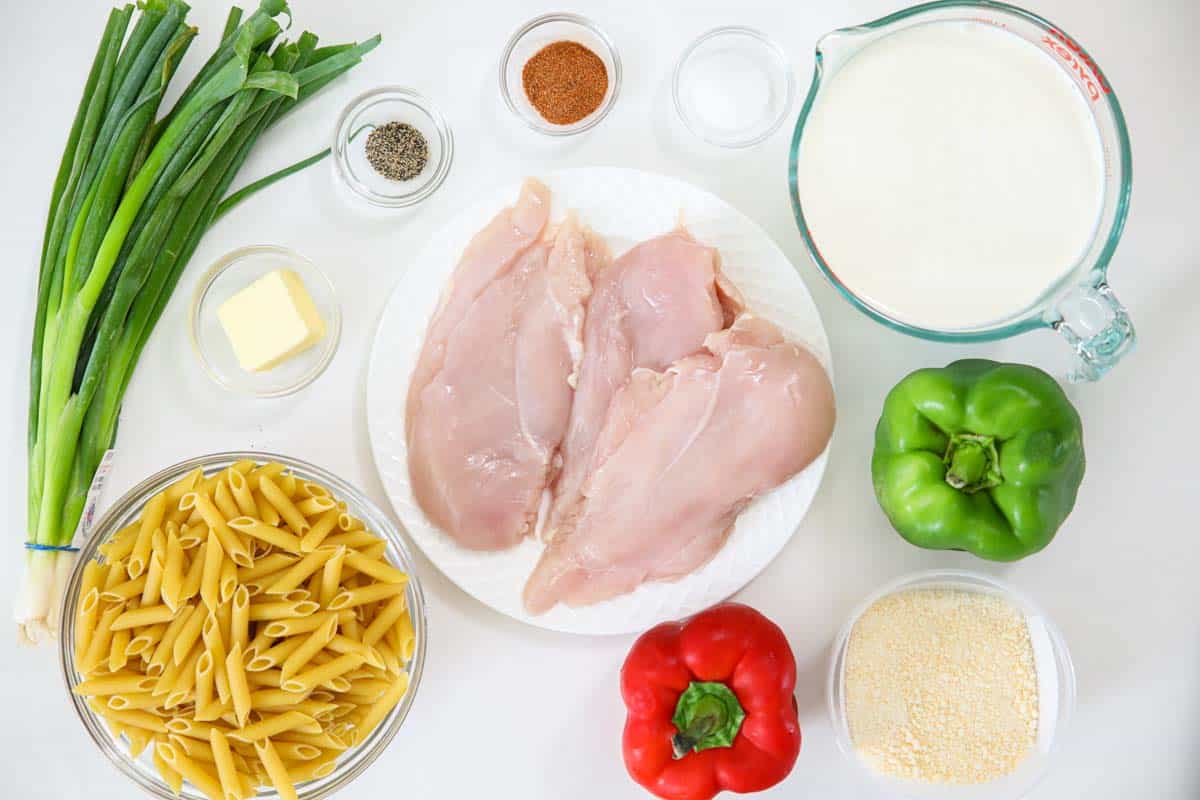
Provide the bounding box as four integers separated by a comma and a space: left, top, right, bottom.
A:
190, 245, 342, 397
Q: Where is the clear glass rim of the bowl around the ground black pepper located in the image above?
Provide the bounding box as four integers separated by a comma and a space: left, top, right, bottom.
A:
332, 84, 454, 209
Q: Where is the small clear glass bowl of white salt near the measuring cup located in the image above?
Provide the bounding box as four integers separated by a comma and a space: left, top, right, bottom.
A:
671, 26, 796, 149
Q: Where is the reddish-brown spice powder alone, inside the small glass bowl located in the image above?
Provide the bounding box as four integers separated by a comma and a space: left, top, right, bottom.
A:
521, 42, 608, 125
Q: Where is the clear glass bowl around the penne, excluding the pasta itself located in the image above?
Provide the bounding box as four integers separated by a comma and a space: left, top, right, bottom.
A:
59, 451, 428, 800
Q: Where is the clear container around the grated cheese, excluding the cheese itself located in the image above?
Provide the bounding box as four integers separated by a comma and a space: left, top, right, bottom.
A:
827, 570, 1075, 800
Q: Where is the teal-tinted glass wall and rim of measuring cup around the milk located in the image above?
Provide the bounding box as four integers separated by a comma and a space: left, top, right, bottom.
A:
787, 0, 1133, 343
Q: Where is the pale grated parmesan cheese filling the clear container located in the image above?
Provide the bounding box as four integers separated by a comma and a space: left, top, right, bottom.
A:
845, 589, 1038, 784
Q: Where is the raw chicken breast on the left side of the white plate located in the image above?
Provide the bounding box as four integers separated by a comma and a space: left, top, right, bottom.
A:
408, 212, 590, 551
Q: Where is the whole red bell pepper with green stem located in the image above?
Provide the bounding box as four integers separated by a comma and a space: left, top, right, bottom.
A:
620, 603, 800, 800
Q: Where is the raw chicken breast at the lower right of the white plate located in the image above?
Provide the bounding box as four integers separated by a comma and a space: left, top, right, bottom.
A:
524, 315, 834, 614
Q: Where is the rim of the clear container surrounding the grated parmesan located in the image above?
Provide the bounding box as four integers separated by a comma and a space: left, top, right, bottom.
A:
826, 569, 1078, 798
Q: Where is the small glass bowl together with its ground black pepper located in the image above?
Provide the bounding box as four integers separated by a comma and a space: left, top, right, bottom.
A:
334, 86, 454, 209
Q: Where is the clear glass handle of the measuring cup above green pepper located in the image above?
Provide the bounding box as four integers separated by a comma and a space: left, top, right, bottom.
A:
1050, 281, 1138, 384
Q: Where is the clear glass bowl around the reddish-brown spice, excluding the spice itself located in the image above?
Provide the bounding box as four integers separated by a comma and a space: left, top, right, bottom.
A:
500, 13, 620, 136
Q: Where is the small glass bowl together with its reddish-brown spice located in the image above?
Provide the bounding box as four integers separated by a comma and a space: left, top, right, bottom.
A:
500, 13, 620, 136
